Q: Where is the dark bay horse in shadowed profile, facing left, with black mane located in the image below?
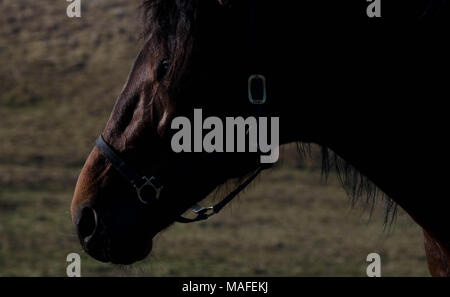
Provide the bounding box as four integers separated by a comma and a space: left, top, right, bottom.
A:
71, 0, 450, 276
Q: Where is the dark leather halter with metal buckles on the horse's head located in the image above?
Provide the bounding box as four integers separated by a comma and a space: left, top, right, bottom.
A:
95, 0, 272, 223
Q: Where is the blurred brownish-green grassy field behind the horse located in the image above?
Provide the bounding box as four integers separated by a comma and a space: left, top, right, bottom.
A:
0, 0, 428, 276
